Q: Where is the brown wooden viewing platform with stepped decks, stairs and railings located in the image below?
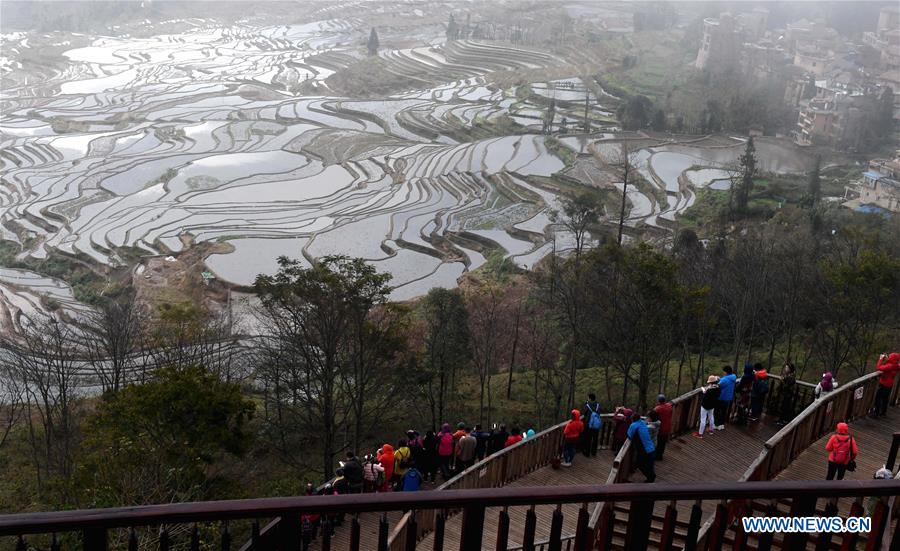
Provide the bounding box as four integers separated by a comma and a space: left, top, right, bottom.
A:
0, 373, 900, 551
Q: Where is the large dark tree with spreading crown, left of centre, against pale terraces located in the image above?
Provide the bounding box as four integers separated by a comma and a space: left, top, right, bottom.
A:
254, 256, 397, 476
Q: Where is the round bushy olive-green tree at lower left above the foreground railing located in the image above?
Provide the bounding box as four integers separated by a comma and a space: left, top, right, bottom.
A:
84, 366, 255, 507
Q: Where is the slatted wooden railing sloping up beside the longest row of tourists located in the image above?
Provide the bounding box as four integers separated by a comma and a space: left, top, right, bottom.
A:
389, 414, 613, 551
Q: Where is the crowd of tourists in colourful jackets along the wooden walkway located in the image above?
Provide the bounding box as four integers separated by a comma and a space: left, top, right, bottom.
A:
303, 353, 900, 539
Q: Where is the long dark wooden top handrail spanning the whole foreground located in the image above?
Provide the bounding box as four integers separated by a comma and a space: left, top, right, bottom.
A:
0, 480, 900, 536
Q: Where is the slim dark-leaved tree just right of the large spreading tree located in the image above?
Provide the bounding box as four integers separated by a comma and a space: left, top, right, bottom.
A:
419, 288, 471, 427
